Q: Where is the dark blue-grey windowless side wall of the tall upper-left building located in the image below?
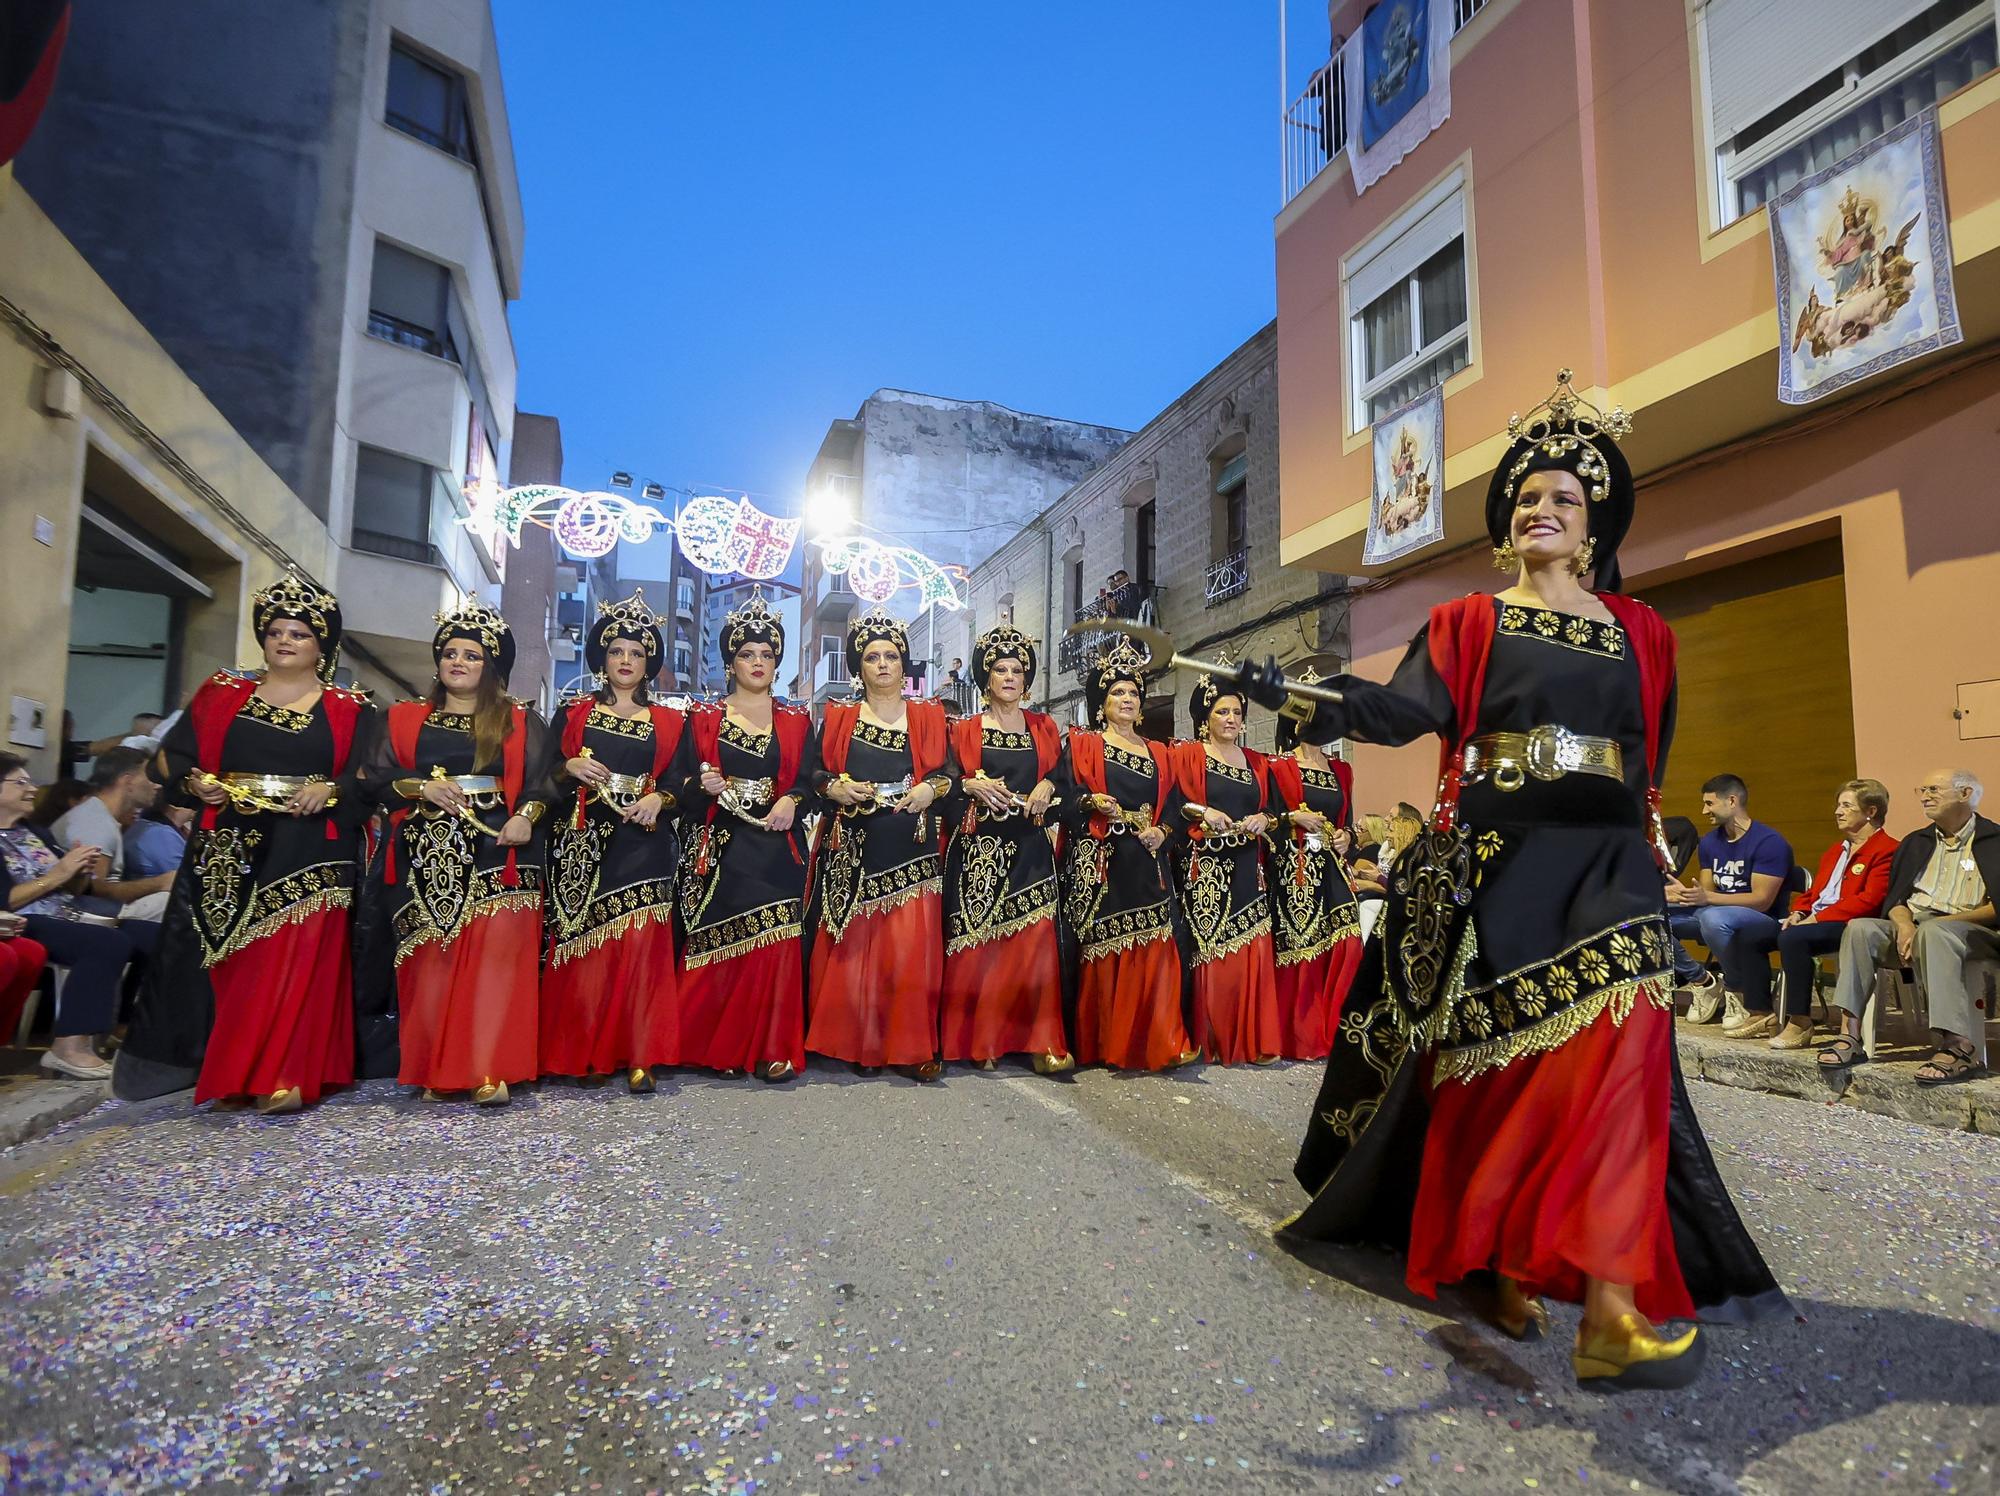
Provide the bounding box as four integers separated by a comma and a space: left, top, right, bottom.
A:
16, 0, 368, 514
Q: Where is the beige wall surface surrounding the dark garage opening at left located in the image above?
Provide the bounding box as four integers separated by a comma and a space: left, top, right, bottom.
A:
0, 172, 332, 778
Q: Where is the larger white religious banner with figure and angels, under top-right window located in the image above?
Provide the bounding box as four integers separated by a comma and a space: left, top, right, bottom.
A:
1770, 110, 1966, 406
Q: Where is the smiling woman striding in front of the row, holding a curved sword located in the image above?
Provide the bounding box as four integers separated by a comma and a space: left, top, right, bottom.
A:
1284, 370, 1784, 1390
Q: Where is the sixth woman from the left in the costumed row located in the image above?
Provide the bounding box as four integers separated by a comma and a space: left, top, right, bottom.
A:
940, 624, 1076, 1074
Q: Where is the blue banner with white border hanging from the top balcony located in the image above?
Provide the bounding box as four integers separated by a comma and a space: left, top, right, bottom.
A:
1340, 0, 1456, 196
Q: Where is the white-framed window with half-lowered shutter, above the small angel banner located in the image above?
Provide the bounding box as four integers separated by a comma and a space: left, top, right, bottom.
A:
1346, 174, 1472, 430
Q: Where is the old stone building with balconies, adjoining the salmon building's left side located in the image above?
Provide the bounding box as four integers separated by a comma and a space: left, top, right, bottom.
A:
956, 326, 1346, 748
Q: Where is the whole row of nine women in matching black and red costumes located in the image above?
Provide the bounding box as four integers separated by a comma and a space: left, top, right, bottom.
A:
114, 574, 1360, 1112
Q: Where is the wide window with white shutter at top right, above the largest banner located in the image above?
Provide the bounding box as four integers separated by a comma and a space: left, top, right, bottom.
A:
1700, 0, 2000, 228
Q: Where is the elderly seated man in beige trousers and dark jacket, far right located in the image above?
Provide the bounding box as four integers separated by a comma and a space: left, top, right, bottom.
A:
1820, 770, 2000, 1086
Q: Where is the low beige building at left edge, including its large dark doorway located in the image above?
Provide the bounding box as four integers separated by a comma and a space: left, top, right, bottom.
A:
0, 168, 334, 780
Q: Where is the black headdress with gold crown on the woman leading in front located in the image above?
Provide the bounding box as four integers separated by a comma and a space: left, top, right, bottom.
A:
1486, 370, 1634, 592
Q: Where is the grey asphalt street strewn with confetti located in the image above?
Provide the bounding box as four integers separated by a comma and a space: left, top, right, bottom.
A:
0, 1066, 2000, 1496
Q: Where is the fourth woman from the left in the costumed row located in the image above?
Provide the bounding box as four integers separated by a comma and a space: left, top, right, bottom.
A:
680, 588, 818, 1082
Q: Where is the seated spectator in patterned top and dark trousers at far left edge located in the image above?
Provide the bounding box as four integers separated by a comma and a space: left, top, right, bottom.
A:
0, 754, 138, 1080
